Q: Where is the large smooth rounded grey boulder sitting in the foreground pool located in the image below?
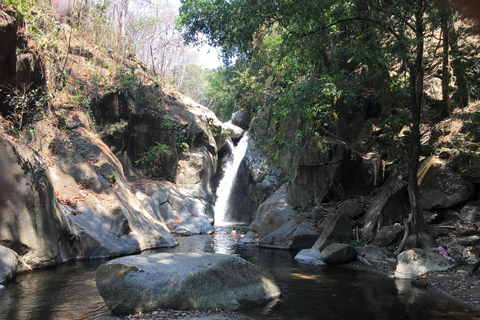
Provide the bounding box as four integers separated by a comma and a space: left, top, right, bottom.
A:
95, 253, 280, 315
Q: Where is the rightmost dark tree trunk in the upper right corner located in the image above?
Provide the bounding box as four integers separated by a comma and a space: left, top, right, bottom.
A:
447, 15, 470, 108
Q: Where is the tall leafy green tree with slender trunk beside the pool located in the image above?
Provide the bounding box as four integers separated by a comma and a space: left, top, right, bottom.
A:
179, 0, 453, 242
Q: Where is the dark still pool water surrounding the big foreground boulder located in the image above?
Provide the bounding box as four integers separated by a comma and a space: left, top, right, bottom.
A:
0, 226, 480, 320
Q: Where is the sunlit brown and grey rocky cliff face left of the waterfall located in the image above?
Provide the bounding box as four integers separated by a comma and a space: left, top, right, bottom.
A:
0, 12, 225, 282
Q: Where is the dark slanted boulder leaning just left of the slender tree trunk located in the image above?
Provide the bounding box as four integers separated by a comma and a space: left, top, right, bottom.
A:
362, 172, 408, 242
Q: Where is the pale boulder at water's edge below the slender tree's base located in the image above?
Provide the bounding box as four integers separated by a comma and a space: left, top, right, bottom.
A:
395, 248, 455, 279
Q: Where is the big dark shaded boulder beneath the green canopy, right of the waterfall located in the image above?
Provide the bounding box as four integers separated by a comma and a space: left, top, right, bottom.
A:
287, 137, 360, 211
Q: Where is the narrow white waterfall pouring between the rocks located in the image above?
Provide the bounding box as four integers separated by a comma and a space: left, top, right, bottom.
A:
215, 133, 248, 225
